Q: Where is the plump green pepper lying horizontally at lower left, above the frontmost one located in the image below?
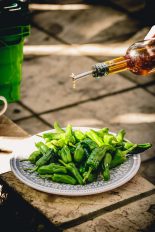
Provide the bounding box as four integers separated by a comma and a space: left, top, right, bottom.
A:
37, 163, 67, 175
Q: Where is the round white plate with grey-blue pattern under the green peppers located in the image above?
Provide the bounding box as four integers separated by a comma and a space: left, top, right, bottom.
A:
10, 127, 141, 196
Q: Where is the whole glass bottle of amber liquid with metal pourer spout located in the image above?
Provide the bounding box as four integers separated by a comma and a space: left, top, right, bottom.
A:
72, 38, 155, 84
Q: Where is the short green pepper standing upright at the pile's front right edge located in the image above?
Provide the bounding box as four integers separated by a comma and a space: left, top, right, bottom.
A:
102, 152, 112, 181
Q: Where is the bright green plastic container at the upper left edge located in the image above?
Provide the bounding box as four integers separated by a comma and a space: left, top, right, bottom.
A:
0, 25, 30, 102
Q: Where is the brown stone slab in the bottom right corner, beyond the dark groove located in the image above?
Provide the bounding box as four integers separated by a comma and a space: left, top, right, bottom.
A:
65, 196, 154, 232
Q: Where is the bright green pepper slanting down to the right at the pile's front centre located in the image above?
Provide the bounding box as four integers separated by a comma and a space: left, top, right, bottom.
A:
59, 160, 83, 185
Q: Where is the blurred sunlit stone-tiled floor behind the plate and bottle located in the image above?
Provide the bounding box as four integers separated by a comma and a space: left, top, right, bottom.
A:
6, 0, 155, 183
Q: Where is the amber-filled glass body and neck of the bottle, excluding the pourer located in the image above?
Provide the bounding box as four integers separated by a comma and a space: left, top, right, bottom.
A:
103, 39, 155, 76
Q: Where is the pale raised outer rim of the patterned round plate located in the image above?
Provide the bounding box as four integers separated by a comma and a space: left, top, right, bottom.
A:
10, 127, 141, 196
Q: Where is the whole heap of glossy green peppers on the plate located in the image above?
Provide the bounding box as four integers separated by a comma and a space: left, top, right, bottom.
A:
21, 122, 152, 185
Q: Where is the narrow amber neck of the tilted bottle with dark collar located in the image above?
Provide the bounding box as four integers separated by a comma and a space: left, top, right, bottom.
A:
93, 56, 129, 78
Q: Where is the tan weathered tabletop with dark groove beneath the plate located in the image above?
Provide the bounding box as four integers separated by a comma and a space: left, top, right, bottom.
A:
0, 116, 155, 232
